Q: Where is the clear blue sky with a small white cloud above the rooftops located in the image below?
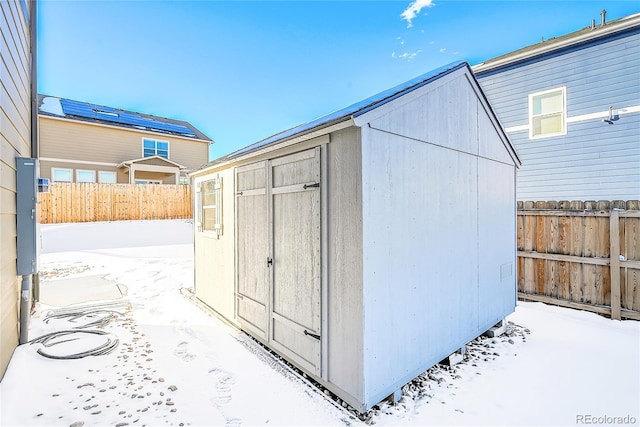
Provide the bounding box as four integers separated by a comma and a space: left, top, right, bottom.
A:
38, 0, 640, 158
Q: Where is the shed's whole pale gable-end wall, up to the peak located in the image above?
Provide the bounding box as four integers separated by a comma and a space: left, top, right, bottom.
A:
359, 74, 516, 403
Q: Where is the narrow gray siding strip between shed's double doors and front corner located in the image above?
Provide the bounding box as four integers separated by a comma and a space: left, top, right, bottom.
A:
323, 128, 364, 406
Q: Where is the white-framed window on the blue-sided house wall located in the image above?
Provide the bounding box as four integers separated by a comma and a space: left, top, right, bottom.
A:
529, 87, 567, 138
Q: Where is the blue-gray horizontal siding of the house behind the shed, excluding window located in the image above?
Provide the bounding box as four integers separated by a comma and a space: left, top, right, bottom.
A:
476, 26, 640, 200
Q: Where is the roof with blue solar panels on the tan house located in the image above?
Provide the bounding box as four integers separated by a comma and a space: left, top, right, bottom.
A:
38, 94, 214, 144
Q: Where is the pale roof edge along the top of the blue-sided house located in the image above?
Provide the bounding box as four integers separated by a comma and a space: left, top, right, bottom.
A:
471, 13, 640, 73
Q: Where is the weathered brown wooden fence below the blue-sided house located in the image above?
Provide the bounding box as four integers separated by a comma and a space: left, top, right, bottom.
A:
517, 200, 640, 320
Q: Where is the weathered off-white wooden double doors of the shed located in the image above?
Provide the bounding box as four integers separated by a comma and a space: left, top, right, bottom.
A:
236, 148, 321, 375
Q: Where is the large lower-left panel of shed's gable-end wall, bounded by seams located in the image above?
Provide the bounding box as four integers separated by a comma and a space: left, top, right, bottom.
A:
362, 129, 478, 408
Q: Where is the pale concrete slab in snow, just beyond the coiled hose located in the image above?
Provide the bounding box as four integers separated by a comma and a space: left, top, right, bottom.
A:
40, 276, 126, 307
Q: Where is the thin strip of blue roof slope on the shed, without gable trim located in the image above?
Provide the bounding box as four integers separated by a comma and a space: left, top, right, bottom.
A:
218, 61, 470, 164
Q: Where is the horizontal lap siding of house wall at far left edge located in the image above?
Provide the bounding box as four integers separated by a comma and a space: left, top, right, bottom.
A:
0, 1, 31, 378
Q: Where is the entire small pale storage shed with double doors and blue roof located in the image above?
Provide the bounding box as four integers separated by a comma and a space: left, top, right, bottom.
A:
192, 62, 519, 411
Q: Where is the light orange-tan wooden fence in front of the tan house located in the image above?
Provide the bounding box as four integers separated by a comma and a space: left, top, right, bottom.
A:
38, 182, 192, 224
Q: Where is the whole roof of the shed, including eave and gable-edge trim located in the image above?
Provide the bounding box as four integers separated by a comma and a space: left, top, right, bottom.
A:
192, 61, 520, 176
